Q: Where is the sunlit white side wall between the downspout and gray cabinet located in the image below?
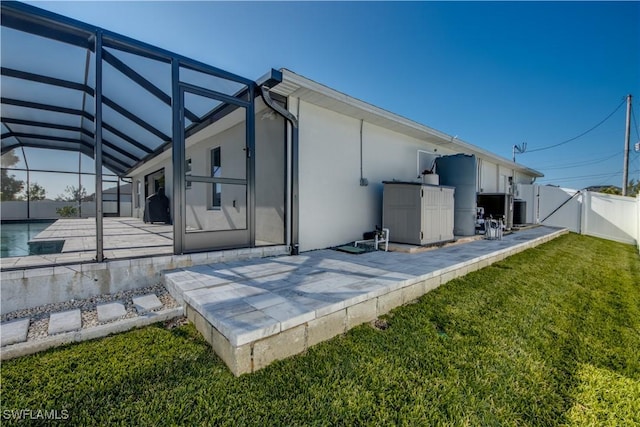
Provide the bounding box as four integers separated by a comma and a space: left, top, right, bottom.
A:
299, 101, 454, 251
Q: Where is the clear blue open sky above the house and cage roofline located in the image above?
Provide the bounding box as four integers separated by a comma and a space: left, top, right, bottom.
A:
22, 2, 640, 188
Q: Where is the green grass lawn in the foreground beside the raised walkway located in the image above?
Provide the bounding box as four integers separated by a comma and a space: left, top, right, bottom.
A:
1, 234, 640, 426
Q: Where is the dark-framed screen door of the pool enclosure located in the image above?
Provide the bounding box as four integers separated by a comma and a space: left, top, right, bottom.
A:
180, 84, 254, 252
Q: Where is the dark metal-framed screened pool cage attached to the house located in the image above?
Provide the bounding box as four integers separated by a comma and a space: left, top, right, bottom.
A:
1, 2, 290, 262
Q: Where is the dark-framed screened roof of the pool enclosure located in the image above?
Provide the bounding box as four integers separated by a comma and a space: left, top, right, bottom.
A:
0, 1, 255, 176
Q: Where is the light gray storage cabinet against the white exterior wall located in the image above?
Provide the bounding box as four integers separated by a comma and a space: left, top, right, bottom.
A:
382, 181, 455, 245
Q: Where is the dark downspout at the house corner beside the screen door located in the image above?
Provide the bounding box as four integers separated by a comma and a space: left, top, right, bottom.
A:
260, 86, 300, 255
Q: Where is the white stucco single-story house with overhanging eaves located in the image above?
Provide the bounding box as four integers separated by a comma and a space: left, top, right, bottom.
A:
128, 69, 542, 252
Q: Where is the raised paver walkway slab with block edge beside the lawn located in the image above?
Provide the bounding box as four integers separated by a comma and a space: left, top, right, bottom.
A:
163, 226, 568, 375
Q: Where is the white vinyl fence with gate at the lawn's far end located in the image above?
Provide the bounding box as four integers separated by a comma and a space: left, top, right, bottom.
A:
516, 184, 640, 250
